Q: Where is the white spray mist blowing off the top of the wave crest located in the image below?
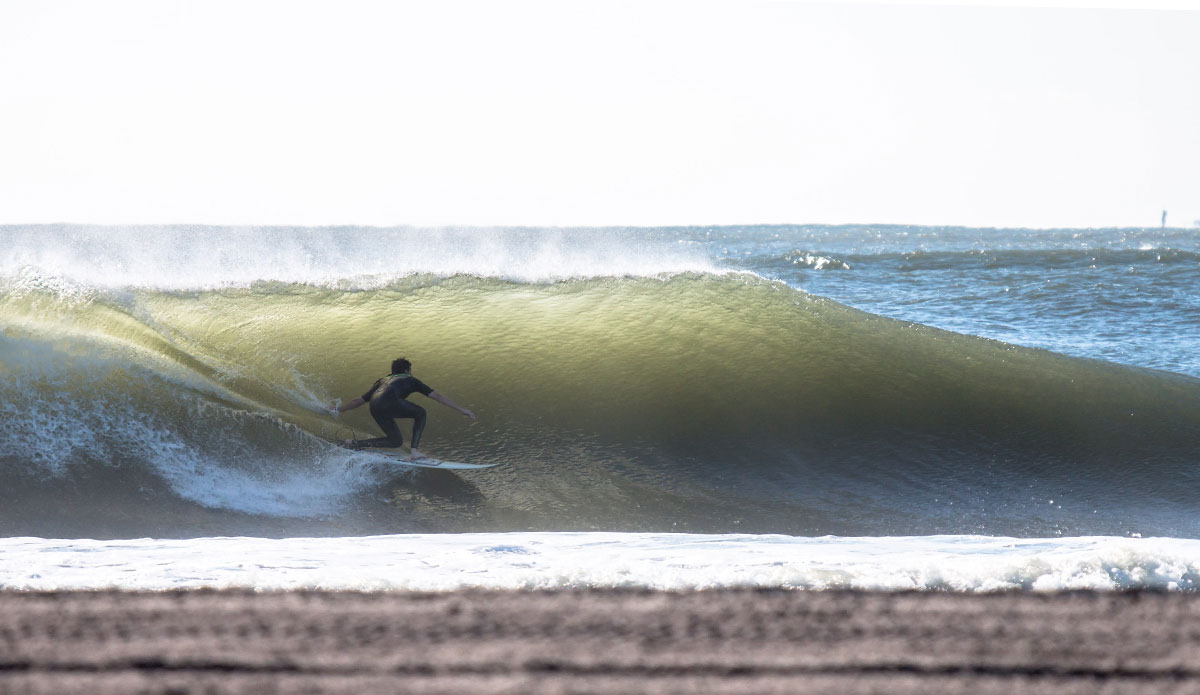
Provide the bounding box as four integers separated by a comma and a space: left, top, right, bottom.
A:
0, 226, 715, 288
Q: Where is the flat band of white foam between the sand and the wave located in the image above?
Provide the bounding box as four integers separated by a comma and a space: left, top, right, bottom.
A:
0, 533, 1200, 592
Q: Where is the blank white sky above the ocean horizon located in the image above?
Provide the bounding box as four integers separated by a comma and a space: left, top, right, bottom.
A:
0, 0, 1200, 227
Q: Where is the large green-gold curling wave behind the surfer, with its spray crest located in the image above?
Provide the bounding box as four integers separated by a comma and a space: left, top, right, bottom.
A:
0, 244, 1200, 538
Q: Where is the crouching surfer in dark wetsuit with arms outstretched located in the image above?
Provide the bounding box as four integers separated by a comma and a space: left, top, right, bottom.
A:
330, 358, 475, 459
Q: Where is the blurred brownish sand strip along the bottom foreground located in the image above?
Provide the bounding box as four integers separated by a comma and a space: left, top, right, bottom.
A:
0, 591, 1200, 694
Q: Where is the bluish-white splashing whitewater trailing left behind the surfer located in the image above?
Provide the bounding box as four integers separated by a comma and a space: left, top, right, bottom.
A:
0, 336, 384, 517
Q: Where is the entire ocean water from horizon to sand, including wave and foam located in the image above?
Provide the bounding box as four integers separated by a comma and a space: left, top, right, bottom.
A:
0, 226, 1200, 591
